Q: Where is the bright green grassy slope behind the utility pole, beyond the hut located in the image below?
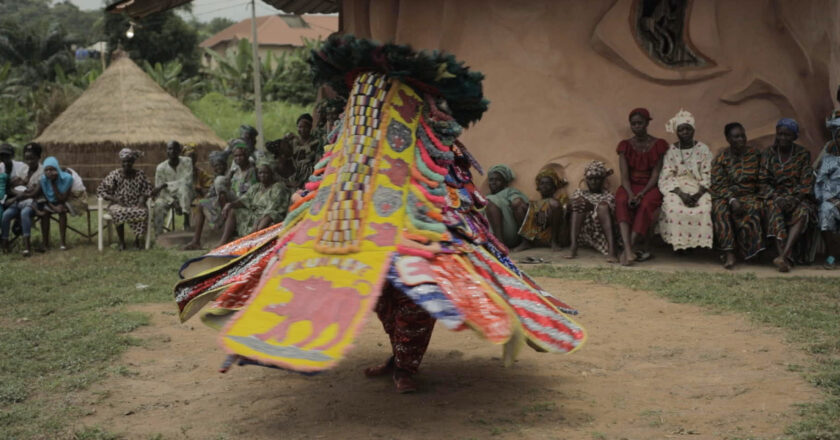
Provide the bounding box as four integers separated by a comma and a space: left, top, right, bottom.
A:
188, 92, 312, 140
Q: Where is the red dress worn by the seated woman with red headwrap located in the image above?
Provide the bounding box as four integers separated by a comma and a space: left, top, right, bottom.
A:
615, 139, 668, 235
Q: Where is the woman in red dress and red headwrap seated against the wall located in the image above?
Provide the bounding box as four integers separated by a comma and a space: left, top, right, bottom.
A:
615, 108, 668, 266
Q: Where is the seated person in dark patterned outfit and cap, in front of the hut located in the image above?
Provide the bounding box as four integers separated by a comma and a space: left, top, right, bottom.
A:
96, 148, 152, 250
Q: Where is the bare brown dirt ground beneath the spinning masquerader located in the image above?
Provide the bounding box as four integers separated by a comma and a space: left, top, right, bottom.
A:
78, 279, 819, 439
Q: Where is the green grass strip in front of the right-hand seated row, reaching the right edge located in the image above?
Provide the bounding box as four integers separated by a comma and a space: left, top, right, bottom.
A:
528, 266, 840, 440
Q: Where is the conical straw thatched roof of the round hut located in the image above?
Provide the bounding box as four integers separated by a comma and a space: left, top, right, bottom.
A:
36, 56, 225, 148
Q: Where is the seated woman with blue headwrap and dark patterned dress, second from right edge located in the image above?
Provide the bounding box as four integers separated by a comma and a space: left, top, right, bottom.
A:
759, 118, 814, 272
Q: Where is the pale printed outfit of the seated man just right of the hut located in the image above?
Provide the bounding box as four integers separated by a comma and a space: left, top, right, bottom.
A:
152, 156, 193, 234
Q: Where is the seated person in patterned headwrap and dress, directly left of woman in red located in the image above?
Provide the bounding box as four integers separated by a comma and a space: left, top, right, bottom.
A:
566, 160, 618, 263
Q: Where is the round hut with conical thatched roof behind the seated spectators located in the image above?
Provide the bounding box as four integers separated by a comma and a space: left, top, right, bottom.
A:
35, 54, 225, 192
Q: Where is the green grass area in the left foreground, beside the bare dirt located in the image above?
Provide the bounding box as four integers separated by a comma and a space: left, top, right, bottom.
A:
0, 245, 190, 439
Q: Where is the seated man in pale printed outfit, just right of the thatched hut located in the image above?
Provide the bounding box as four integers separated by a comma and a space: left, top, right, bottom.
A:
152, 141, 193, 235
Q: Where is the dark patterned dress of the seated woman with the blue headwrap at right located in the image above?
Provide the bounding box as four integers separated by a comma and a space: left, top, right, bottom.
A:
759, 144, 814, 240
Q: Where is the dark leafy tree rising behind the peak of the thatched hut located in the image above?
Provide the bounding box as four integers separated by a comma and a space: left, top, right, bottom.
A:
105, 10, 200, 77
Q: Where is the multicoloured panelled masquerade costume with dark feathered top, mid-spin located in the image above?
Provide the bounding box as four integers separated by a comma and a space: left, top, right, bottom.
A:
175, 36, 584, 372
